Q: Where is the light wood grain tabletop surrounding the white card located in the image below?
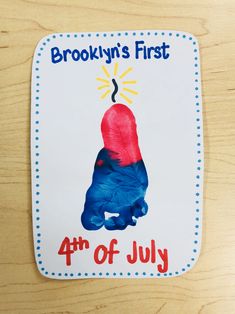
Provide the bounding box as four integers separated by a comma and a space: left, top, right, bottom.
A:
0, 0, 235, 314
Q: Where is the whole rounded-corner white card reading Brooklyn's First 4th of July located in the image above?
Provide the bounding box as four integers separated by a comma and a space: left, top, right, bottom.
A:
31, 30, 203, 279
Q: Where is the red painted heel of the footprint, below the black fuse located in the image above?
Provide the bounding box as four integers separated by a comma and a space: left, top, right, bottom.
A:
101, 104, 142, 166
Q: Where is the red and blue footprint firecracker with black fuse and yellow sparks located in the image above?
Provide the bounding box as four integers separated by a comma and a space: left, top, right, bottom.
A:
81, 64, 148, 230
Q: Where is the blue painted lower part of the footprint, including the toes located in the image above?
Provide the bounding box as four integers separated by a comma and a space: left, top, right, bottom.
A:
81, 148, 148, 230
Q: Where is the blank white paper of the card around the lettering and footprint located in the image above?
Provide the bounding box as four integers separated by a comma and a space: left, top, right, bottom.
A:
32, 31, 203, 278
